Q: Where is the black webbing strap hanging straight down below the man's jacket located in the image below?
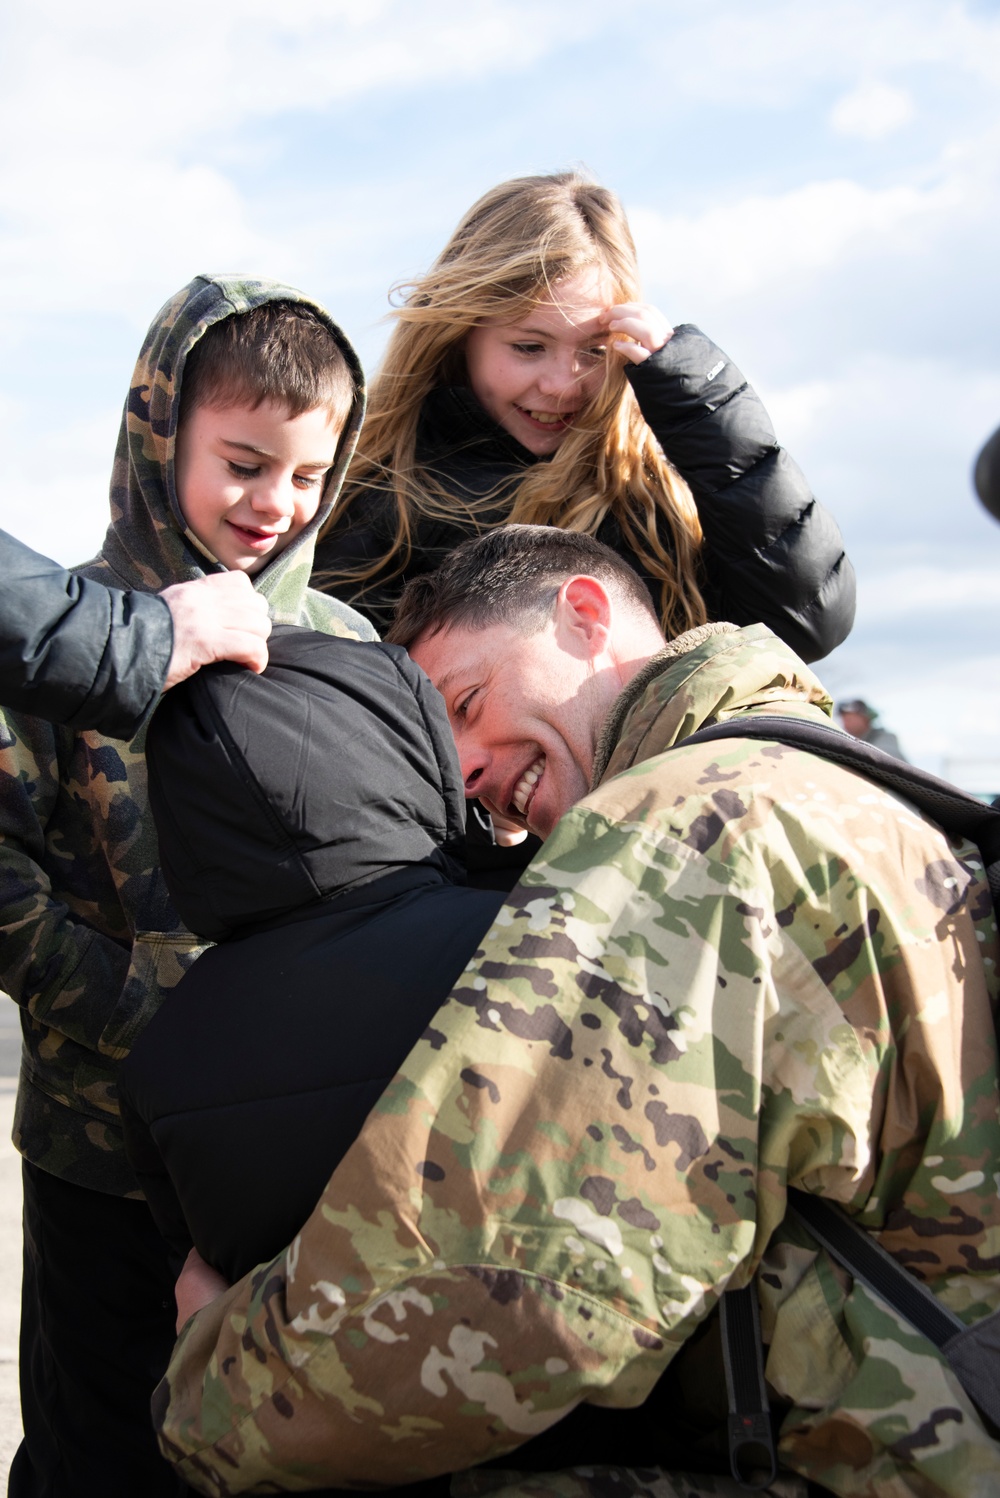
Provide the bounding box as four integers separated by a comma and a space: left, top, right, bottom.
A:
719, 1285, 778, 1488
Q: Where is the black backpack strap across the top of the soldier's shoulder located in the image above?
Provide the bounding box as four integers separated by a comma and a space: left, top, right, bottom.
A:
675, 713, 1000, 905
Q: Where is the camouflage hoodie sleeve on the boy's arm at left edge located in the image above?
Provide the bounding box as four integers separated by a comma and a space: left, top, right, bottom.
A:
0, 713, 130, 1050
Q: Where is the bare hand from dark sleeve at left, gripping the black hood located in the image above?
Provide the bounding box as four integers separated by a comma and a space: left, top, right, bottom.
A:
160, 572, 271, 692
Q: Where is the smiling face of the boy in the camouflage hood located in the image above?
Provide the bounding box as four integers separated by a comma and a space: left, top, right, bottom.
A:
175, 400, 341, 577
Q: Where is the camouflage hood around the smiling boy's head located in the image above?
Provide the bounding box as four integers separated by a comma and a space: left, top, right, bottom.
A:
95, 276, 365, 622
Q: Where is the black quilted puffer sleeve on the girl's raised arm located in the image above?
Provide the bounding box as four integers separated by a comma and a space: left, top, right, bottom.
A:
629, 325, 855, 661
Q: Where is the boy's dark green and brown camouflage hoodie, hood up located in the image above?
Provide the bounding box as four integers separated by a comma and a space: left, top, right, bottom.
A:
0, 276, 373, 1195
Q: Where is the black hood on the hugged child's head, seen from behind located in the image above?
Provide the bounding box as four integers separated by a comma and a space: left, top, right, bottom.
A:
147, 628, 466, 941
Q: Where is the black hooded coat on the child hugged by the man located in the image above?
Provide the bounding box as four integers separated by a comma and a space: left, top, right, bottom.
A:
121, 628, 501, 1279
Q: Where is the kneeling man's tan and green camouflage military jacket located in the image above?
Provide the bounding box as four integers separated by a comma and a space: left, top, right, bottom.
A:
154, 625, 1000, 1498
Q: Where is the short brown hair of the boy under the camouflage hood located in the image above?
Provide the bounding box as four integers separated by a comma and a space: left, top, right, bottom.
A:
178, 301, 356, 425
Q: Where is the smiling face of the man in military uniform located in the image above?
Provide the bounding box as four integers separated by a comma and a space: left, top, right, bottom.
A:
410, 622, 601, 837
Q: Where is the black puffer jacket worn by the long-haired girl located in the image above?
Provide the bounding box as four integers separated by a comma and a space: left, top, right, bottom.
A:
313, 325, 855, 661
